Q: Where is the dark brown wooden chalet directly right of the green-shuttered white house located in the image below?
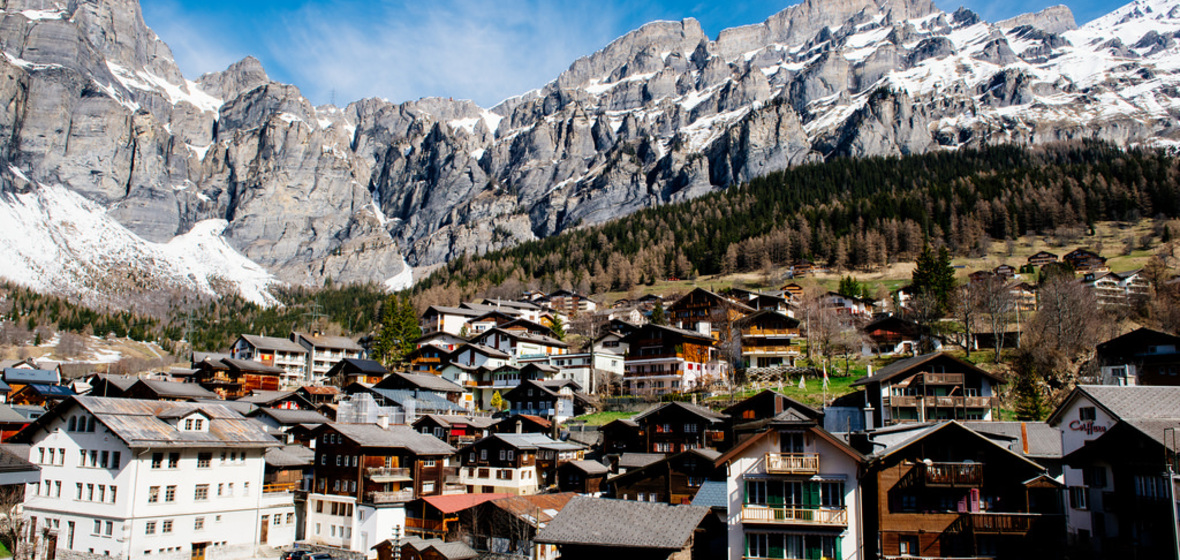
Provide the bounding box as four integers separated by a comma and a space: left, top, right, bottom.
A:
861, 422, 1066, 559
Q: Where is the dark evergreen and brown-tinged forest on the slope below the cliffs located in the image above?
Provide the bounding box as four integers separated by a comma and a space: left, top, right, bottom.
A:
415, 141, 1180, 303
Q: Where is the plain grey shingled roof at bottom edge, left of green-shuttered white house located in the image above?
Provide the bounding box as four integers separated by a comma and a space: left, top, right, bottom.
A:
535, 496, 710, 549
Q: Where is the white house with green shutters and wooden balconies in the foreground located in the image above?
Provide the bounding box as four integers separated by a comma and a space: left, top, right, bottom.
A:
714, 408, 868, 560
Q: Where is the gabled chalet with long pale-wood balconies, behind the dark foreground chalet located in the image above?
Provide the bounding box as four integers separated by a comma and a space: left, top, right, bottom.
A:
852, 353, 1003, 427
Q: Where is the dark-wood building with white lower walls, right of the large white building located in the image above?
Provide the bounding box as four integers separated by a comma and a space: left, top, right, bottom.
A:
304, 423, 454, 558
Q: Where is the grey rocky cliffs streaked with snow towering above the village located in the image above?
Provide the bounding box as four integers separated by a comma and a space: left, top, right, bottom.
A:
0, 0, 1180, 306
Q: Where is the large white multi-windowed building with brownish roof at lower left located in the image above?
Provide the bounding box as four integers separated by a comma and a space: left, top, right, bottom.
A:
14, 396, 295, 560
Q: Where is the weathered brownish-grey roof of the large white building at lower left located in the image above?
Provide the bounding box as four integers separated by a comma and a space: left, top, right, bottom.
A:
13, 396, 278, 448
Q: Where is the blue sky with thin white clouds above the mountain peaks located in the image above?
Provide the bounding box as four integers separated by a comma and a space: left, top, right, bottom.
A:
142, 0, 1129, 107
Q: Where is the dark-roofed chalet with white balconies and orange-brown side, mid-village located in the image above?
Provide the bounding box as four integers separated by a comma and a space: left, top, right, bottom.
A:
623, 323, 726, 395
